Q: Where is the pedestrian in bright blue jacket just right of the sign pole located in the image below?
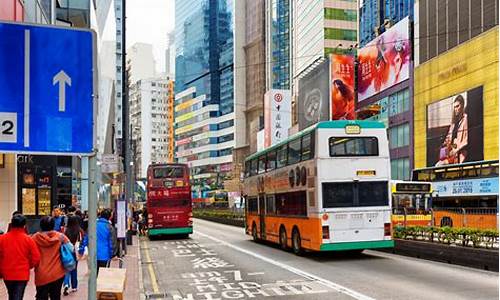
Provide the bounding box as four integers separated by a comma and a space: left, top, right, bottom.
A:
97, 209, 118, 273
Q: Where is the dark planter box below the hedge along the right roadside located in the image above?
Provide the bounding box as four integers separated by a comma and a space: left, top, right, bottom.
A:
380, 239, 498, 272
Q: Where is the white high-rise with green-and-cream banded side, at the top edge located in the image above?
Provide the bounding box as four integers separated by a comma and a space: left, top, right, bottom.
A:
292, 0, 358, 84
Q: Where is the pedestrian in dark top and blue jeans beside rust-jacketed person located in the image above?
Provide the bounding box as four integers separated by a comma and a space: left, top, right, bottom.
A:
63, 206, 83, 296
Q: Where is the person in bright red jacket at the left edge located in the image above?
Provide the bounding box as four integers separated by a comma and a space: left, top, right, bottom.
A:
0, 214, 40, 300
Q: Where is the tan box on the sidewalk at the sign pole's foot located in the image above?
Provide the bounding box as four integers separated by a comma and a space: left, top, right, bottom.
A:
97, 268, 127, 300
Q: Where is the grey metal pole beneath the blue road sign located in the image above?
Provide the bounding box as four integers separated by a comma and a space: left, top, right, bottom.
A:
87, 154, 97, 300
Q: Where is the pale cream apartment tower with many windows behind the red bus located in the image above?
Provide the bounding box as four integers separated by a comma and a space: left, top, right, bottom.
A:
129, 78, 170, 178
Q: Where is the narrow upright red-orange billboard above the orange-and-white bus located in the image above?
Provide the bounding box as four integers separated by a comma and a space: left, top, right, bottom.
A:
330, 54, 356, 120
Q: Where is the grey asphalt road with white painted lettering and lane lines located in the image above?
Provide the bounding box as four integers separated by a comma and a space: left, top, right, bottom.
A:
141, 219, 498, 300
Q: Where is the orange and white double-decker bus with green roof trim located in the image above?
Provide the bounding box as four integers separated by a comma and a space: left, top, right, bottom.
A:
244, 121, 394, 254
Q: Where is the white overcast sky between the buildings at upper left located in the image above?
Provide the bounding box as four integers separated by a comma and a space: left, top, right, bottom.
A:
103, 0, 175, 72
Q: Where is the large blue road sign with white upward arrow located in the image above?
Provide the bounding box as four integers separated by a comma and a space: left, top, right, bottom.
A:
0, 22, 95, 154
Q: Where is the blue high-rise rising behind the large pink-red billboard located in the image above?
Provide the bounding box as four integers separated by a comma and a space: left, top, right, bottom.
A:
359, 0, 414, 47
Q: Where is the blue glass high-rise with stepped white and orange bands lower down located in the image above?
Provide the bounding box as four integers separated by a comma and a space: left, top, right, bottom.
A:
174, 0, 235, 191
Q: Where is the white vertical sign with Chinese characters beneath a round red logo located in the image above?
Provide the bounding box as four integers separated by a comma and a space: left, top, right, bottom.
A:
264, 90, 292, 147
